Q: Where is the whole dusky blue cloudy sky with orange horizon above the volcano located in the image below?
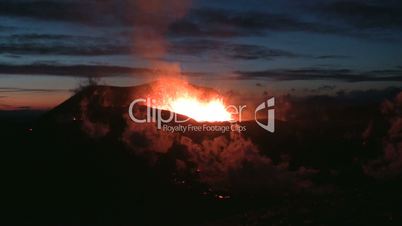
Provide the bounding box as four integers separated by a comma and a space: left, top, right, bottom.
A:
0, 0, 402, 109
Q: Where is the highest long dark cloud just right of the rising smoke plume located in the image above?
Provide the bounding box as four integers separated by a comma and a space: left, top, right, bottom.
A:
171, 8, 346, 38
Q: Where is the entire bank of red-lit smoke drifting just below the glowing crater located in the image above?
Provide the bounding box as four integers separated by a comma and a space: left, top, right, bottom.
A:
122, 115, 316, 193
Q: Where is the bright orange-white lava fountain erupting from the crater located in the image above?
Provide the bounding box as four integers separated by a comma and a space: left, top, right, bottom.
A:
148, 79, 232, 122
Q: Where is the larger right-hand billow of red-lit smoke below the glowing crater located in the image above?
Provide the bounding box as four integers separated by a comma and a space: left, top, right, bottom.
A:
180, 132, 313, 193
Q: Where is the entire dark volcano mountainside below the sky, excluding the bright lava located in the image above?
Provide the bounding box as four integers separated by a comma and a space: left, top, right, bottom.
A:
3, 83, 400, 225
